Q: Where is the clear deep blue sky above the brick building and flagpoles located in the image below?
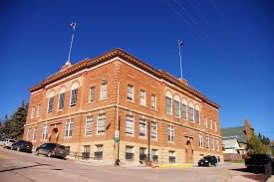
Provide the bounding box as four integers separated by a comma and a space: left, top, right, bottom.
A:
0, 0, 274, 139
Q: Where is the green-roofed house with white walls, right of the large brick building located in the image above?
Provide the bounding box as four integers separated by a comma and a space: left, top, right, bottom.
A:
221, 119, 253, 160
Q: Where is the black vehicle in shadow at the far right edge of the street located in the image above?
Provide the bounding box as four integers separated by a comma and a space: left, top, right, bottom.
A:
245, 154, 274, 171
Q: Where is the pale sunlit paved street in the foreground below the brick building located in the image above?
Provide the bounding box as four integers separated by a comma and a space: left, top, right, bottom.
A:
0, 147, 273, 182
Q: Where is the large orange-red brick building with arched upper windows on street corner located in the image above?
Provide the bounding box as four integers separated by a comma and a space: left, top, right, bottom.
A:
24, 49, 223, 163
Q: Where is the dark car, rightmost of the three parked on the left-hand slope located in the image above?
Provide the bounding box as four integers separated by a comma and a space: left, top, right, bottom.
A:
35, 143, 67, 159
